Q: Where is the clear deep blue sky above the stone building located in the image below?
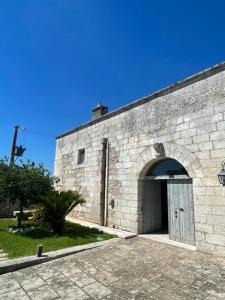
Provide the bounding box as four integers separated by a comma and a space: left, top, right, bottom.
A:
0, 0, 225, 170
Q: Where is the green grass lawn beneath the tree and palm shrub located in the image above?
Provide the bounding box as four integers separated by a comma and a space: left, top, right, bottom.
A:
0, 219, 113, 258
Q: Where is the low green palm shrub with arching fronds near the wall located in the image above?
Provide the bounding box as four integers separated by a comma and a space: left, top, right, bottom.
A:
41, 190, 85, 234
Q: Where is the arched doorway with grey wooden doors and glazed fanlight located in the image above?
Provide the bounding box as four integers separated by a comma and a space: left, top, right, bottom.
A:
142, 158, 195, 245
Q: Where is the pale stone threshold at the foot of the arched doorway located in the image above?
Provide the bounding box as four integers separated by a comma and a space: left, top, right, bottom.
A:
138, 233, 196, 251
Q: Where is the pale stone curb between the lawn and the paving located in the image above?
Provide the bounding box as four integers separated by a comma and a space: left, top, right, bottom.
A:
0, 238, 120, 275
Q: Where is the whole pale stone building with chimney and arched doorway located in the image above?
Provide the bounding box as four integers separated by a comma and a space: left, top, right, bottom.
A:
55, 62, 225, 256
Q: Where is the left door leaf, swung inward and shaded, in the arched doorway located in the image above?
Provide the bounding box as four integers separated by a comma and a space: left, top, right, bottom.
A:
142, 180, 162, 233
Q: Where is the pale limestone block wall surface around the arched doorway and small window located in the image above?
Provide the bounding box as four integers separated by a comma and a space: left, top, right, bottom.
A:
55, 64, 225, 255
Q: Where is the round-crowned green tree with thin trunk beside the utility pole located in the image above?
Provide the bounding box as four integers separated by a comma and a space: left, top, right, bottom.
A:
0, 159, 54, 227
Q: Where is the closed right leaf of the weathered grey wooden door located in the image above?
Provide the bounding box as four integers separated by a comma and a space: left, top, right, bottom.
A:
167, 179, 195, 245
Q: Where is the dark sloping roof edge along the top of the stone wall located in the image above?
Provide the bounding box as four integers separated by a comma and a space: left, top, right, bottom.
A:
56, 61, 225, 139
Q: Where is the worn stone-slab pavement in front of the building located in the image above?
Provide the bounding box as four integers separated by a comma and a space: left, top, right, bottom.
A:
0, 238, 225, 300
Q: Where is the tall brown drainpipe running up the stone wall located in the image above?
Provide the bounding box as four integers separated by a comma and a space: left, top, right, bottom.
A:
100, 138, 107, 226
